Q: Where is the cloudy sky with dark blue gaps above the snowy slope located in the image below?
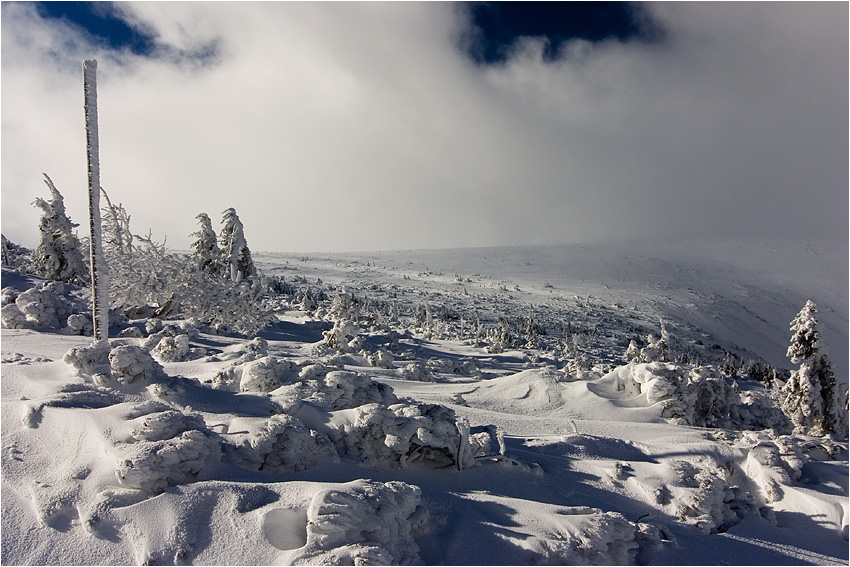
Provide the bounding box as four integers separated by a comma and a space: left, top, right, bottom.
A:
0, 1, 850, 252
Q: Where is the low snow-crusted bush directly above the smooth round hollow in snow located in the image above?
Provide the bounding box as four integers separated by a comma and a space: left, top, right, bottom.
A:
224, 414, 338, 474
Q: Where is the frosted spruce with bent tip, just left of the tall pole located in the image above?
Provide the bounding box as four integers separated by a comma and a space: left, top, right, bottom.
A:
31, 173, 89, 285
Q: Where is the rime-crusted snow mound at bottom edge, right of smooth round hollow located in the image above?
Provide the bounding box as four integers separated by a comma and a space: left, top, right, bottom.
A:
291, 480, 428, 565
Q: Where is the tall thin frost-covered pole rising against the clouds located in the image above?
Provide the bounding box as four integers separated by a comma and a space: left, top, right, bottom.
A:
83, 59, 109, 343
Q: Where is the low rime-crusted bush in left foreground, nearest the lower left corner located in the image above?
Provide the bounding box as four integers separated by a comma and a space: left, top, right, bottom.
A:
116, 429, 220, 494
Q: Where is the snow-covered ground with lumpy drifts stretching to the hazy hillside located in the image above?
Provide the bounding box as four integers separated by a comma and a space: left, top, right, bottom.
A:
0, 243, 850, 565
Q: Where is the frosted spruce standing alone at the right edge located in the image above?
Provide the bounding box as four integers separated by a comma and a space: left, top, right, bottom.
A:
782, 301, 847, 438
